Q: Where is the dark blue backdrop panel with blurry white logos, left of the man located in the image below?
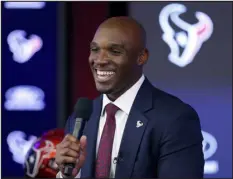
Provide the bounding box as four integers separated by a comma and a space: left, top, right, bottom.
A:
1, 2, 58, 177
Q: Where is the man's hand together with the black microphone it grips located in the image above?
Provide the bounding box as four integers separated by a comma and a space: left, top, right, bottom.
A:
55, 98, 92, 177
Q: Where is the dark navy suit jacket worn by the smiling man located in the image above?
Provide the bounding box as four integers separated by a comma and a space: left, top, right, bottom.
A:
66, 79, 204, 178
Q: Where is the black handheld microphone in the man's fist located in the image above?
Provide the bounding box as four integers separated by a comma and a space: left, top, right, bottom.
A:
64, 98, 92, 177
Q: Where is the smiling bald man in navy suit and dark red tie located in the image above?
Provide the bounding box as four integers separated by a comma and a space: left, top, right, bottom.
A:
56, 17, 204, 178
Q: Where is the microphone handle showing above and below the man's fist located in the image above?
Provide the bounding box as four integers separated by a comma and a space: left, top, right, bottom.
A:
64, 118, 85, 177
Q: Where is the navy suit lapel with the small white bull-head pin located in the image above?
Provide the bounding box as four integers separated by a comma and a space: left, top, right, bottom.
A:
115, 79, 155, 178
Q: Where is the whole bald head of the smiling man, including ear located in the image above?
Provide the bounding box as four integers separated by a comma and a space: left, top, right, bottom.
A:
89, 17, 148, 100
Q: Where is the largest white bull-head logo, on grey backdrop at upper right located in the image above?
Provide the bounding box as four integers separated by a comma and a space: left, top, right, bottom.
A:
159, 3, 213, 67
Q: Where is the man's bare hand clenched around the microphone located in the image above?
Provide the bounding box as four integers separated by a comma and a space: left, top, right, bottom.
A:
55, 134, 87, 178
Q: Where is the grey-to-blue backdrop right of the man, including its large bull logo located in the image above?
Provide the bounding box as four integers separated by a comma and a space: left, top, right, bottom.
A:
129, 2, 232, 178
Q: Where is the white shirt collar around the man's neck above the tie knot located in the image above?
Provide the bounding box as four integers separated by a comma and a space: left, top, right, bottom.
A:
101, 75, 145, 115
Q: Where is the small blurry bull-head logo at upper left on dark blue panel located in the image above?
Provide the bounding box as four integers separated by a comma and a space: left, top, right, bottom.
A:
7, 30, 43, 63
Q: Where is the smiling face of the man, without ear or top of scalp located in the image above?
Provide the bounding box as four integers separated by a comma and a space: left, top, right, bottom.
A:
89, 27, 139, 98
